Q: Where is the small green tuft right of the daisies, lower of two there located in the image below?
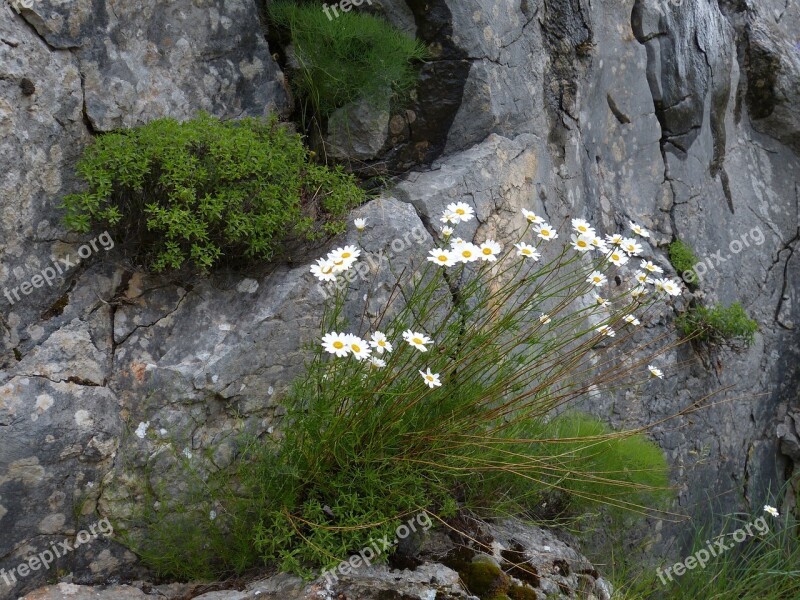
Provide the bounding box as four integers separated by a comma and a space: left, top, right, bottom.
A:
677, 302, 758, 346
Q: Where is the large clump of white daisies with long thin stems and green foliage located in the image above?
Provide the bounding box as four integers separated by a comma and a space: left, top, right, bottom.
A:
122, 213, 684, 577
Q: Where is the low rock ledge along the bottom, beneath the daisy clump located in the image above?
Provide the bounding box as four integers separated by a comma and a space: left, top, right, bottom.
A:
21, 521, 612, 600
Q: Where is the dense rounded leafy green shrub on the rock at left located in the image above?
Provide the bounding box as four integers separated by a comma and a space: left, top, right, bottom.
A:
63, 114, 364, 271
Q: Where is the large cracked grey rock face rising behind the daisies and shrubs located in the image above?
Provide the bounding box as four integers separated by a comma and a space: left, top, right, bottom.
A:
0, 0, 800, 598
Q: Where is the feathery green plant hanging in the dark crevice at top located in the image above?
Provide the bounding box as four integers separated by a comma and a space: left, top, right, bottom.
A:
268, 0, 427, 119
